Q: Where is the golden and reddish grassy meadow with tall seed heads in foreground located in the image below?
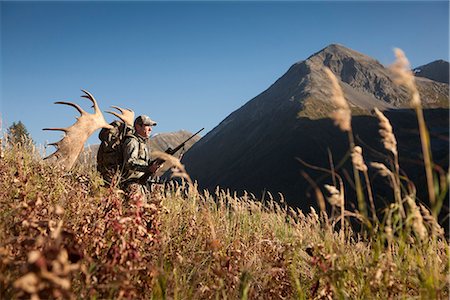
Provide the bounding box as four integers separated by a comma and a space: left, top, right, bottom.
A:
0, 50, 449, 299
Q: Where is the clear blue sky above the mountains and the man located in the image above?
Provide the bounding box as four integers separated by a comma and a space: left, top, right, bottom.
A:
1, 1, 449, 148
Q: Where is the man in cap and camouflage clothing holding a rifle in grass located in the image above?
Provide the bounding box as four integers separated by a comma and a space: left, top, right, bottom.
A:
122, 115, 160, 202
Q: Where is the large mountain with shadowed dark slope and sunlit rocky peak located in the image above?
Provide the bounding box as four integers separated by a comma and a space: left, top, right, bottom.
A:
182, 44, 448, 216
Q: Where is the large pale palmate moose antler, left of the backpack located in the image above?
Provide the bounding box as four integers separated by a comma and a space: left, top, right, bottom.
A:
43, 90, 112, 170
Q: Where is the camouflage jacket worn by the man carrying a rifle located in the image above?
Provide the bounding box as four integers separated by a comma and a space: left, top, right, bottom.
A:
122, 134, 150, 182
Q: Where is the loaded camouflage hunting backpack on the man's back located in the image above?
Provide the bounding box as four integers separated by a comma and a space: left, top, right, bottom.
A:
97, 121, 134, 183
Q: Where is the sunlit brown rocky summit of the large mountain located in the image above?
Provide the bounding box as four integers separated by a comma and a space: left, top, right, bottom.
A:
296, 44, 400, 110
